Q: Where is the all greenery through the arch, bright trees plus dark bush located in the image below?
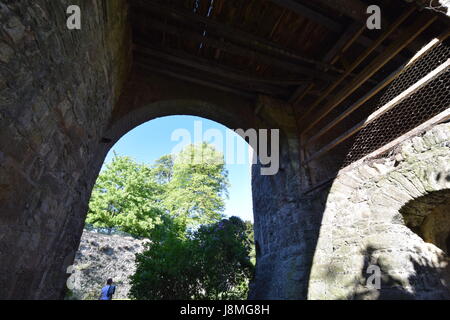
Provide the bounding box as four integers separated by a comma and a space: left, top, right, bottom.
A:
86, 144, 254, 299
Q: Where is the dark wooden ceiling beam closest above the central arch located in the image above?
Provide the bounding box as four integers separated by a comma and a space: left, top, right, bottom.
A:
135, 46, 289, 96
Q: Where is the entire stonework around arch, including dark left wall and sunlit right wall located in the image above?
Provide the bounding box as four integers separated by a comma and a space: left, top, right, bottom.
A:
0, 0, 450, 299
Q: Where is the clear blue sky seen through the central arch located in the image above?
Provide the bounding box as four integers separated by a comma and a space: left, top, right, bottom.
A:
105, 116, 253, 222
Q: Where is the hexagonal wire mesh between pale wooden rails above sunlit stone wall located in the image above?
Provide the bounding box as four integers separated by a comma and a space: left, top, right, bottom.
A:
343, 41, 450, 167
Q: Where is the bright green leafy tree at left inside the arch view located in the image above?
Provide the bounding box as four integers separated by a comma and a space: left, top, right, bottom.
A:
86, 155, 164, 237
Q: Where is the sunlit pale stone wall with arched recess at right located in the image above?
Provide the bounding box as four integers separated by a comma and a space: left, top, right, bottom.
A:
309, 123, 450, 299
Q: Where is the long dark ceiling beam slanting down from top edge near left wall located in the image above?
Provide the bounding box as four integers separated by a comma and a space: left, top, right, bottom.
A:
130, 0, 342, 74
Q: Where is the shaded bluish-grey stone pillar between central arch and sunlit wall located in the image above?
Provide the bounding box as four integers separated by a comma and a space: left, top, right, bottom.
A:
250, 97, 321, 299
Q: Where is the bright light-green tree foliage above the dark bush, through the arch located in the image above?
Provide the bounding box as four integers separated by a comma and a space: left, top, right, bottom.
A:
86, 144, 228, 237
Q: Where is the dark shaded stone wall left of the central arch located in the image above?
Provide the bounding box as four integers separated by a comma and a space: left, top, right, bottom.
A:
0, 0, 131, 299
